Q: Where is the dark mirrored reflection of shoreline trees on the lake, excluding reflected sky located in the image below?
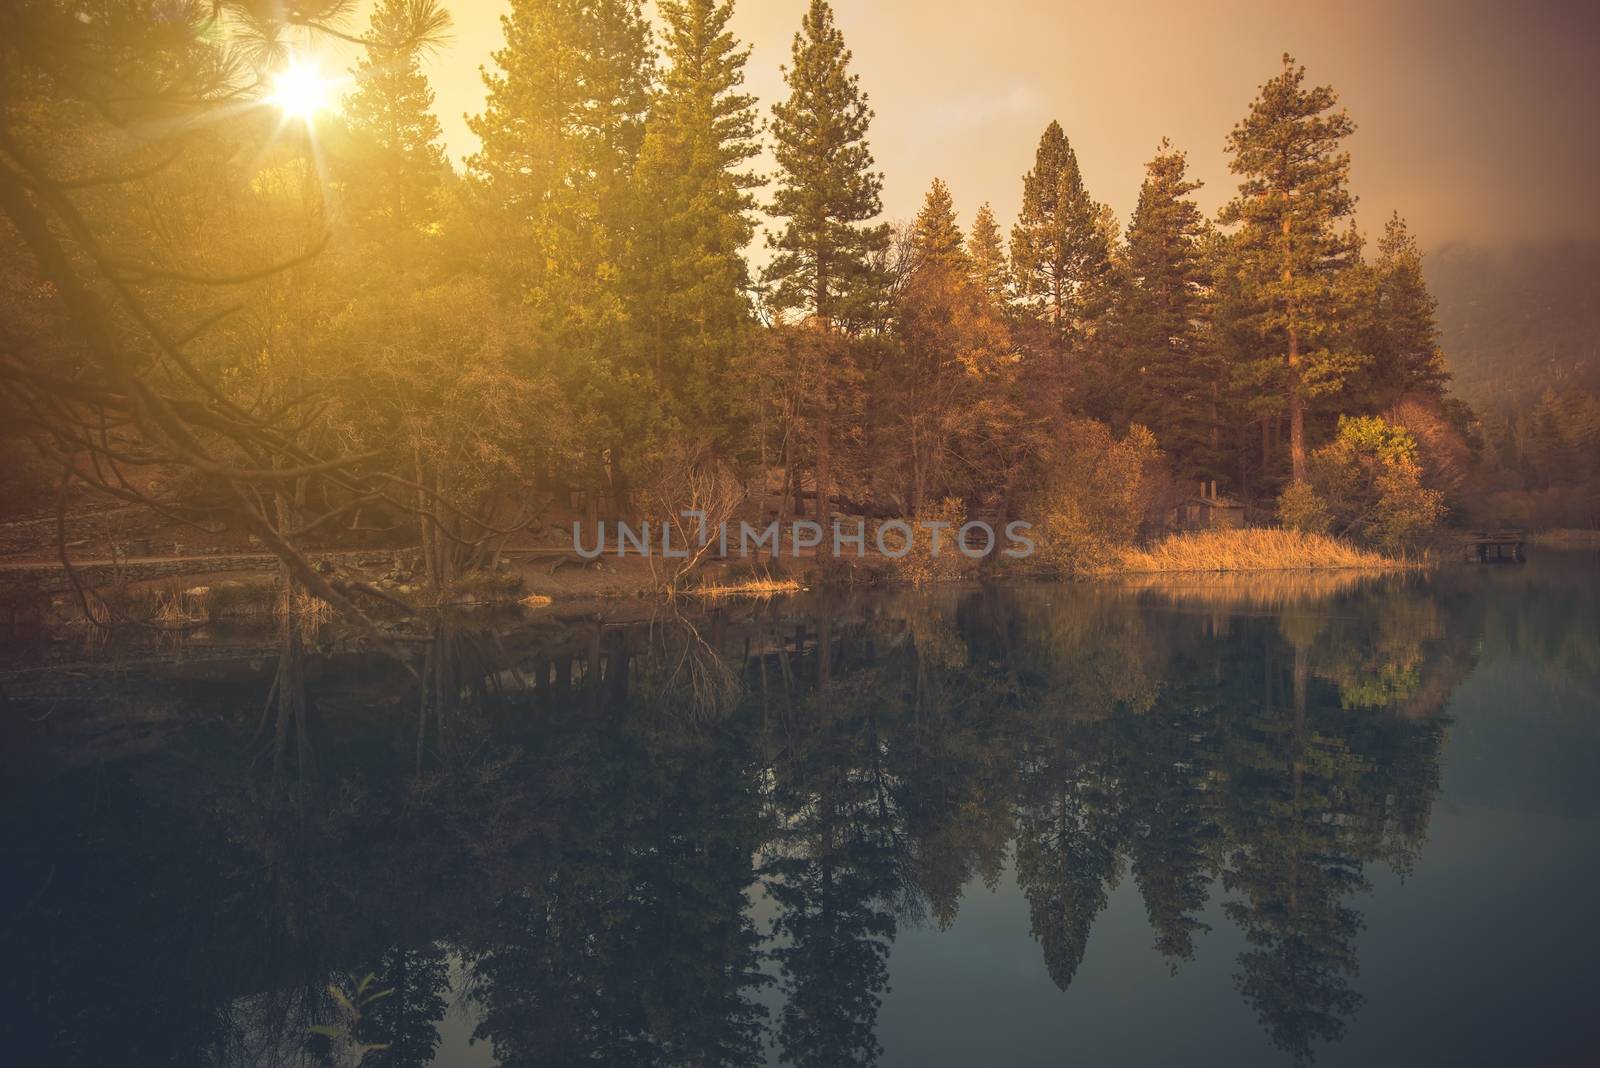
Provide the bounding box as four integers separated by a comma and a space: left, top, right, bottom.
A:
0, 562, 1600, 1066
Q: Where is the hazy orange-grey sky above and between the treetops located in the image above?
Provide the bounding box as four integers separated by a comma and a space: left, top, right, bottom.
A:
393, 0, 1600, 248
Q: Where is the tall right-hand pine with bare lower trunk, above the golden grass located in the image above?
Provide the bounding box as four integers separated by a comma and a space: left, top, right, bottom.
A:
1221, 53, 1362, 481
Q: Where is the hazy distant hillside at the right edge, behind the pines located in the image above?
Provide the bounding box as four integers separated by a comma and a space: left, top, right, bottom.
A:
1424, 241, 1600, 408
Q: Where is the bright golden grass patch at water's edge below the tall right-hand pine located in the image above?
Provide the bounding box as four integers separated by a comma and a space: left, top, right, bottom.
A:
1107, 529, 1406, 574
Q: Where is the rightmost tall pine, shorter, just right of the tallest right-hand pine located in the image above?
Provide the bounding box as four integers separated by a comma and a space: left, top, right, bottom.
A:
1370, 213, 1450, 409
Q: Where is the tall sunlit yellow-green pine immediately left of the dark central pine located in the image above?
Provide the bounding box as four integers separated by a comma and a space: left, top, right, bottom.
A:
635, 0, 760, 444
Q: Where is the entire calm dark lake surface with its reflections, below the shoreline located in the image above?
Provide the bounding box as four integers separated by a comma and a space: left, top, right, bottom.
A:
0, 552, 1600, 1068
